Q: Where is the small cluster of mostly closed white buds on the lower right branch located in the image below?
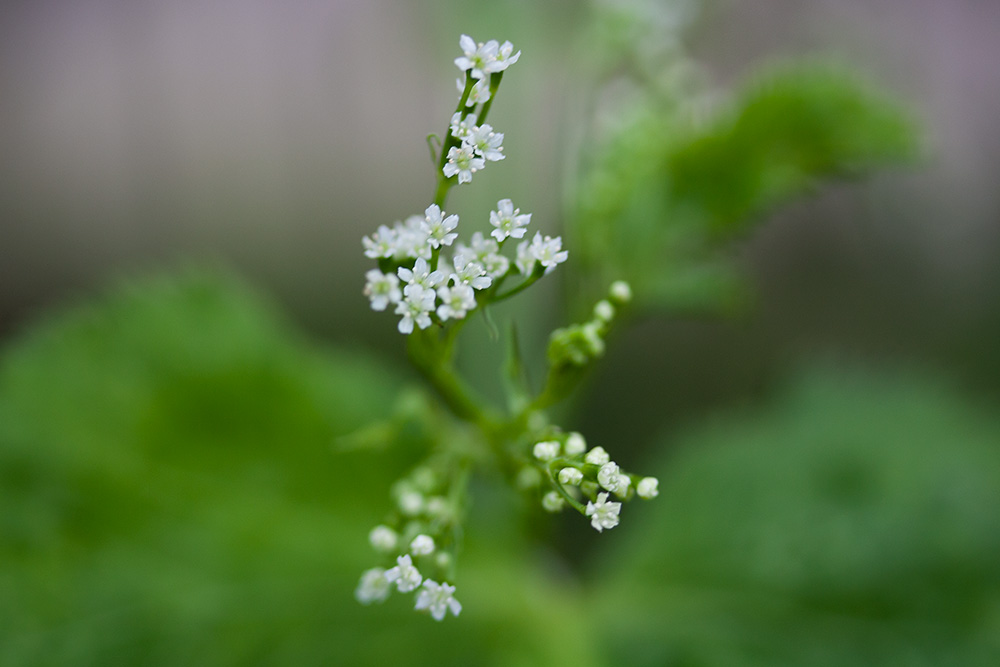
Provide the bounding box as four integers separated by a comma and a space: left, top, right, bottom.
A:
532, 433, 659, 532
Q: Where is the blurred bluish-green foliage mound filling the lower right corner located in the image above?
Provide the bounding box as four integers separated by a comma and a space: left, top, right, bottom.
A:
595, 372, 1000, 667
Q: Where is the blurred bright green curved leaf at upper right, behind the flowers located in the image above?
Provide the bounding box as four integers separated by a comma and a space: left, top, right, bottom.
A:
573, 64, 916, 310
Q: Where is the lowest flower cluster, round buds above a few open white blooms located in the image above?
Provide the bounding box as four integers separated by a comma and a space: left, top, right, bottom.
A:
354, 467, 462, 621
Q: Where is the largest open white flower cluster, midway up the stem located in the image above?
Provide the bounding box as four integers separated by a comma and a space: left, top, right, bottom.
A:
362, 199, 568, 334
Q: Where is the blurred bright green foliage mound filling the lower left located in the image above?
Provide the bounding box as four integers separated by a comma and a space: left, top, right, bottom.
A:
0, 272, 587, 666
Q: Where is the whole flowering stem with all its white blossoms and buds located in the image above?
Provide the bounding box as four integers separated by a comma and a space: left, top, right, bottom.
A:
355, 35, 657, 621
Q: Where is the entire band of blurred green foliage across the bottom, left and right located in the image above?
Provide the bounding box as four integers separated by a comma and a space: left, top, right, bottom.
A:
0, 273, 1000, 666
